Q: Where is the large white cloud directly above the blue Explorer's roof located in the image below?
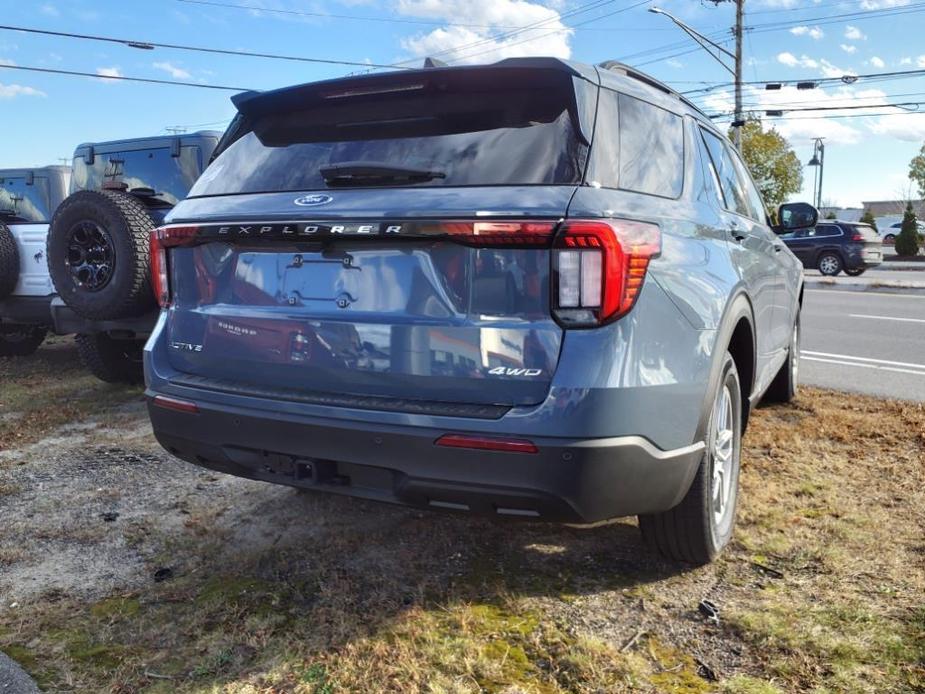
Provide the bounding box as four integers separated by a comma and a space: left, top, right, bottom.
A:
397, 0, 573, 63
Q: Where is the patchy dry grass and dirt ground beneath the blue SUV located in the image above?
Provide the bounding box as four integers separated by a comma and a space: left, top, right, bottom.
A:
0, 347, 925, 693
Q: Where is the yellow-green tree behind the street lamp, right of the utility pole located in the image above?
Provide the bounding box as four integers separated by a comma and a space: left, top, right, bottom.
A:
728, 120, 803, 210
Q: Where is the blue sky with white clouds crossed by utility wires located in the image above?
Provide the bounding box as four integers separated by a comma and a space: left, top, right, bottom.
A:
0, 0, 925, 206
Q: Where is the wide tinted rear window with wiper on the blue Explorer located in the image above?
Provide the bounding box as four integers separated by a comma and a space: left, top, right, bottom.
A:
190, 77, 588, 196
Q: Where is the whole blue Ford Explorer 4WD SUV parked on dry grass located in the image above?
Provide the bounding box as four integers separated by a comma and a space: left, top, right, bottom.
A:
145, 59, 816, 563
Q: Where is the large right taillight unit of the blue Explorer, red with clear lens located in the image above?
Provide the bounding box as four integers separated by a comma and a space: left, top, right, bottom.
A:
553, 220, 662, 327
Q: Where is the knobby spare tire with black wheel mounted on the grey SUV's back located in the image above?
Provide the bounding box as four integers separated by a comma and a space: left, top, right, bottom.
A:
47, 190, 155, 320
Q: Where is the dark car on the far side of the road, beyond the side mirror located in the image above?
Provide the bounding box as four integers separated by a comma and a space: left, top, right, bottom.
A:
780, 221, 883, 277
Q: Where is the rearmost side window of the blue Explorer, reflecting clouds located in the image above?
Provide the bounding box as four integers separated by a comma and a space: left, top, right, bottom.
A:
618, 94, 684, 198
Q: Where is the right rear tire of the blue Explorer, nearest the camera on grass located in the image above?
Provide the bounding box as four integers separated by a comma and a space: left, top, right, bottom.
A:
639, 352, 742, 565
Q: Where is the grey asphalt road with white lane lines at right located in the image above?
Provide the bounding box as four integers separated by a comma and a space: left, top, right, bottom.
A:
800, 289, 925, 402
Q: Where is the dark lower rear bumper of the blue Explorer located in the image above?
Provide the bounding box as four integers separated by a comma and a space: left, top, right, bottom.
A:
147, 390, 703, 523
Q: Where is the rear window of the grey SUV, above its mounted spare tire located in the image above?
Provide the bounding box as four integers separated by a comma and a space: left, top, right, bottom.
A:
71, 146, 202, 205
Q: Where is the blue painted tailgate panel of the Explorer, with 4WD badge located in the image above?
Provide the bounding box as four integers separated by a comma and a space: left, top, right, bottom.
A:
167, 186, 574, 406
